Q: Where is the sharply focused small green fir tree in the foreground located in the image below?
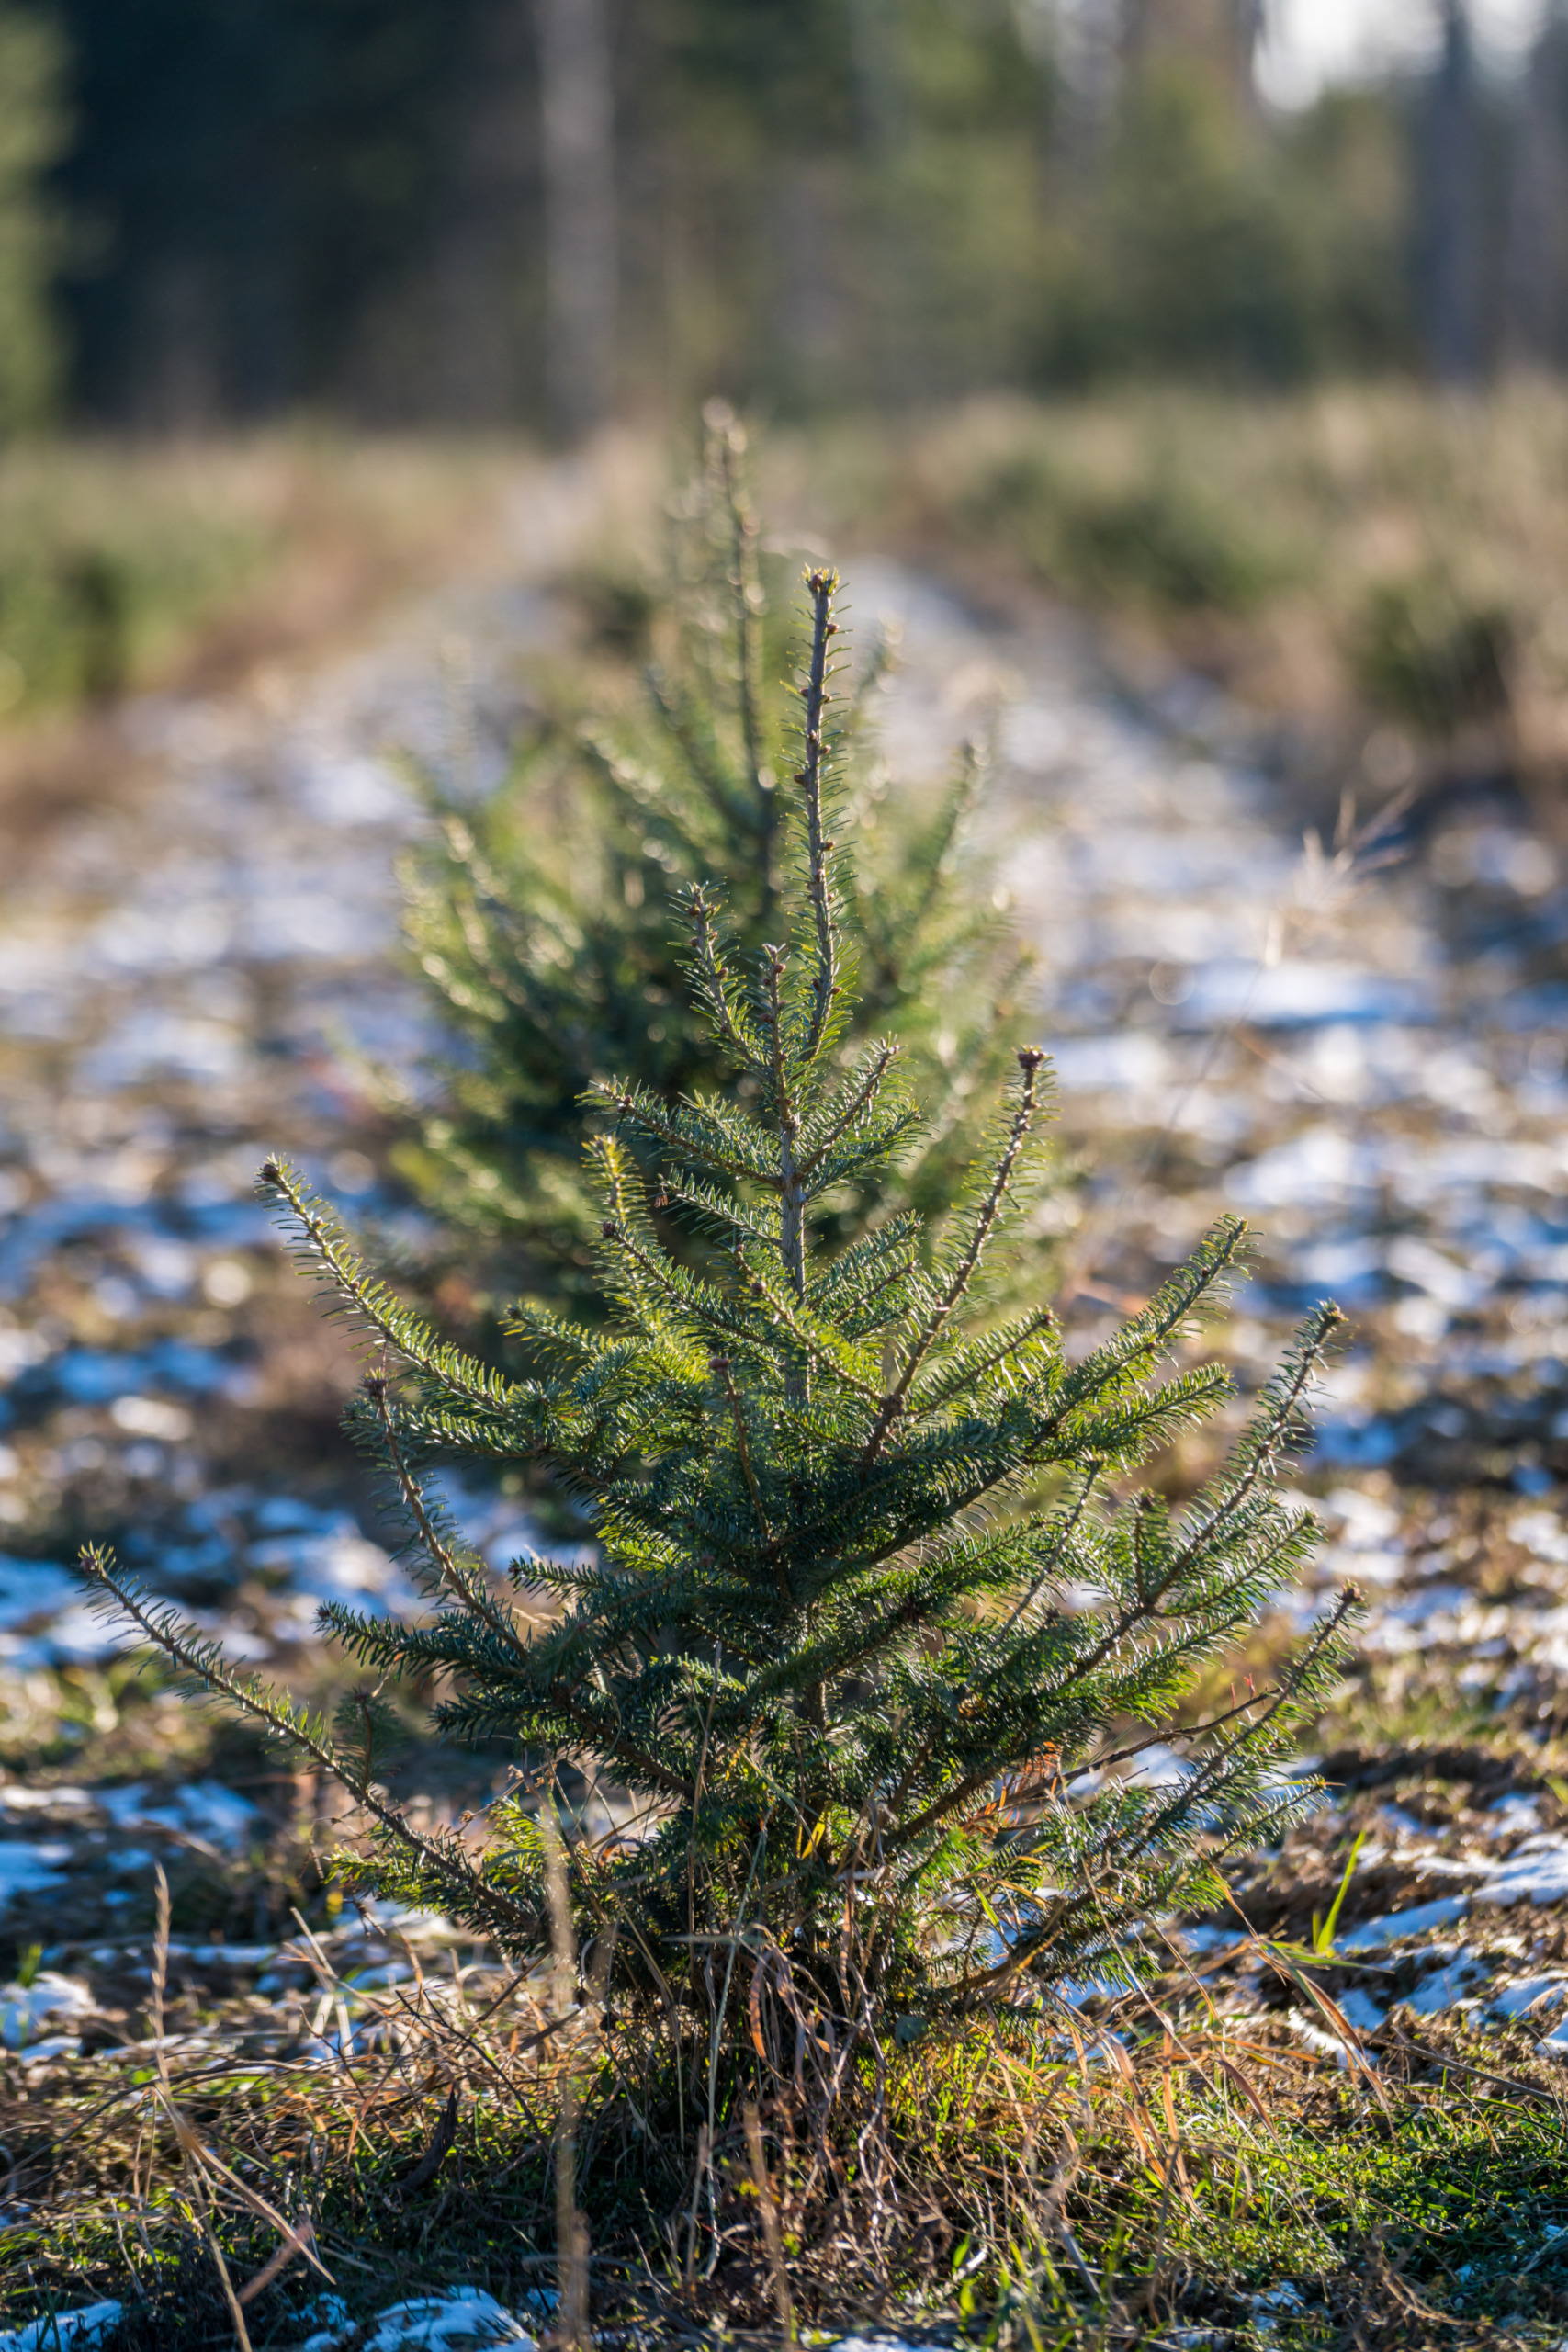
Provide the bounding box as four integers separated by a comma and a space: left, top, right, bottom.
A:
85, 555, 1352, 2154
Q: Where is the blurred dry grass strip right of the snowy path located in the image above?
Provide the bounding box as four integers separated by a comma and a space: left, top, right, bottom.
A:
771, 381, 1568, 783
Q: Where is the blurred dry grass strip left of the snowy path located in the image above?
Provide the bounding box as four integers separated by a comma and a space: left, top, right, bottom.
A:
0, 435, 538, 840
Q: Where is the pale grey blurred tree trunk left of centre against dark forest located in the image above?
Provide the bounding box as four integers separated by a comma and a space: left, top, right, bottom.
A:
536, 0, 618, 440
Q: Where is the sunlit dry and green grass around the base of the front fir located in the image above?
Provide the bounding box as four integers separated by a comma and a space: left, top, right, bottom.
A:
15, 1871, 1568, 2352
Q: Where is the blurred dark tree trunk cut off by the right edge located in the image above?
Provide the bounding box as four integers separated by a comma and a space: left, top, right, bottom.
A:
1505, 0, 1568, 367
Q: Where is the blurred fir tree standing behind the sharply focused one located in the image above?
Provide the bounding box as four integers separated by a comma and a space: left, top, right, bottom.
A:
400, 402, 1027, 1312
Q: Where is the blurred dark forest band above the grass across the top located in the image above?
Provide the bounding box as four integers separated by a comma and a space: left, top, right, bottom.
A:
0, 0, 1568, 437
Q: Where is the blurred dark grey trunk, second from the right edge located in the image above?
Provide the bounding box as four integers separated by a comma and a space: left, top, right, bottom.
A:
1416, 0, 1485, 386
